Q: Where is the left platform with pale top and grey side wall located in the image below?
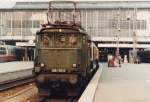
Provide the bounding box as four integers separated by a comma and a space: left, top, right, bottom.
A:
0, 61, 33, 84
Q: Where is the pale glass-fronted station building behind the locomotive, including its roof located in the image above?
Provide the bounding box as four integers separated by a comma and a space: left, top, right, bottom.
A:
0, 1, 150, 60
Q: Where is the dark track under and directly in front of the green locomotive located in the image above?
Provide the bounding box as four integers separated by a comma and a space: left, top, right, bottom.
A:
39, 69, 97, 102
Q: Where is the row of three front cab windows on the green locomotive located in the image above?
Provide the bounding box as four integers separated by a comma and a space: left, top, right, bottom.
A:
38, 33, 81, 48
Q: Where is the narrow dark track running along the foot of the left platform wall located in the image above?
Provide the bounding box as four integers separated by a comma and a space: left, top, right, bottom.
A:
0, 76, 35, 91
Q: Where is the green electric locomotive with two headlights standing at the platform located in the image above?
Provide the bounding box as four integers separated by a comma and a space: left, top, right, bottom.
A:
33, 1, 98, 96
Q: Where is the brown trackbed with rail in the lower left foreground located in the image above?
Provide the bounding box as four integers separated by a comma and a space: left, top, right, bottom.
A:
0, 83, 38, 102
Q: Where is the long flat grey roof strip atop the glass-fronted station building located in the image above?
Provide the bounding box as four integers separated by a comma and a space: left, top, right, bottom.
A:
0, 1, 150, 10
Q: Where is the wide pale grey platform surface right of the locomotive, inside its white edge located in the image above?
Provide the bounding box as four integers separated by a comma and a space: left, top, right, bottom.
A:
93, 64, 150, 102
